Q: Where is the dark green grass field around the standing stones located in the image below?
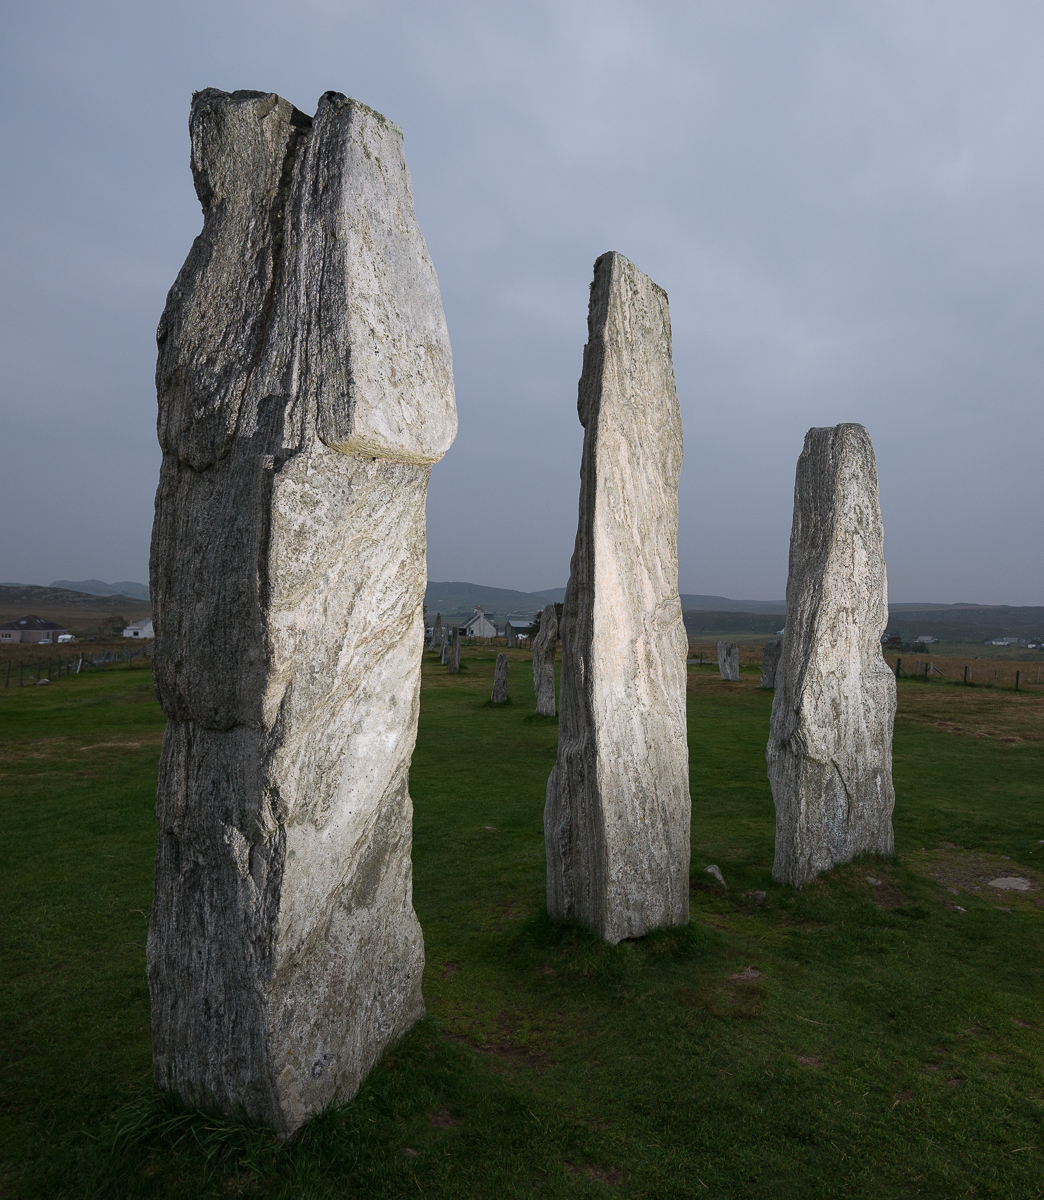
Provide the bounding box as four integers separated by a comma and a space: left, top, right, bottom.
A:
0, 647, 1044, 1198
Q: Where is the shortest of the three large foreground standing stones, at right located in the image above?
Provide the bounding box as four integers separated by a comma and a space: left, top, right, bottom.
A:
767, 425, 895, 887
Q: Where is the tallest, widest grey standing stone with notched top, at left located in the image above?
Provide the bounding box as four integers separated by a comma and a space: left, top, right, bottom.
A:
148, 89, 456, 1135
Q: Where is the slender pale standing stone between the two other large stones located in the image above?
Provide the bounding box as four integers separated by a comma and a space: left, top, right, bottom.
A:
544, 253, 691, 942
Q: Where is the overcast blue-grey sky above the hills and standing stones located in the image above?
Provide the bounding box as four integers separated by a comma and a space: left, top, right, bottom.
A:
0, 0, 1044, 604
